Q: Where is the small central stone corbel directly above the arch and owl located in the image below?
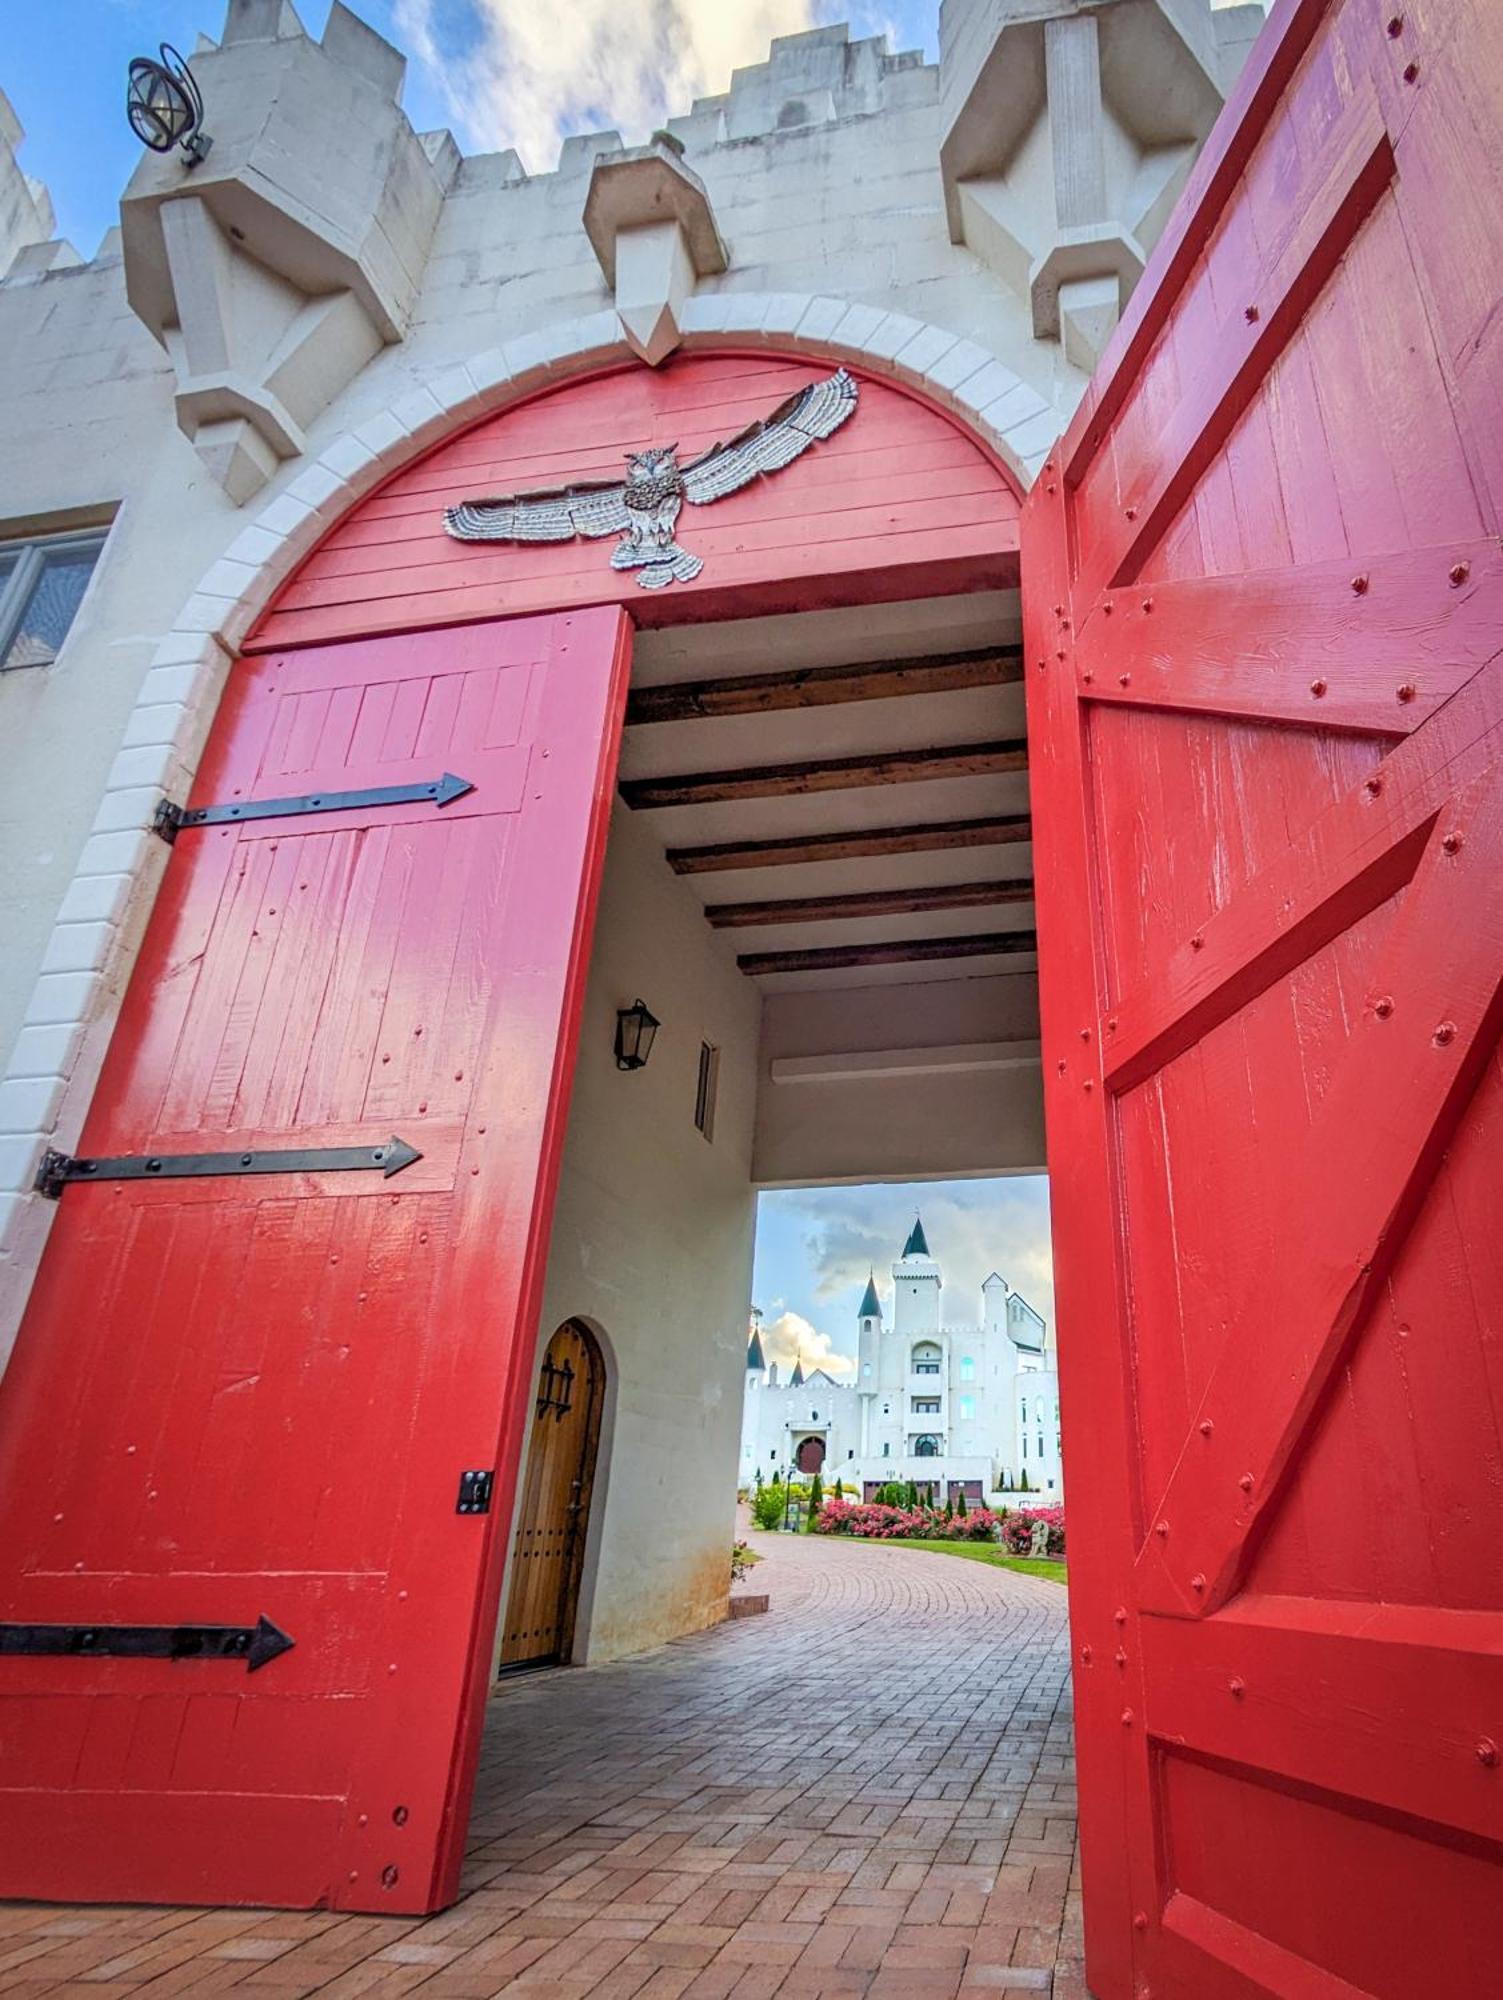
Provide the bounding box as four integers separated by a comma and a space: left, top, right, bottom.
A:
584, 132, 728, 368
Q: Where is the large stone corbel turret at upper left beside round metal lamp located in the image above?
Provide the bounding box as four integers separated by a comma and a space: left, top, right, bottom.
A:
120, 0, 458, 506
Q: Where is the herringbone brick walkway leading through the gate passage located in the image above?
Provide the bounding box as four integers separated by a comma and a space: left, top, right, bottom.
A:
0, 1536, 1085, 2000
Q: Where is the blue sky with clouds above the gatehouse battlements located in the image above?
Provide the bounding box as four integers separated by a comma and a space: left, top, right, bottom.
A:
14, 0, 1271, 256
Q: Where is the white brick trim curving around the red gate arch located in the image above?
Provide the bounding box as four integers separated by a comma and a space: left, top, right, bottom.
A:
0, 292, 1063, 1368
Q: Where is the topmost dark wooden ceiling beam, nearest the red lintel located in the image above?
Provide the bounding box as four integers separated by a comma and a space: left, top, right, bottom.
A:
626, 646, 1023, 728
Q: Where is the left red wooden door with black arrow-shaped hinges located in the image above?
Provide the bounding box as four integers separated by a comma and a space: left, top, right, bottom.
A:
0, 608, 628, 1910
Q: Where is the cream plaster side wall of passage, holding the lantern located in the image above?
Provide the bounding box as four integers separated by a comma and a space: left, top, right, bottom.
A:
527, 804, 761, 1660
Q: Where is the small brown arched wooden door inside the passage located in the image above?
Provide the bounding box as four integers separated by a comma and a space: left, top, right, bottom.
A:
500, 1320, 606, 1672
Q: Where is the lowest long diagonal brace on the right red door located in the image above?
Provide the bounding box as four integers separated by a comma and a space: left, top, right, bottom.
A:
1137, 772, 1503, 1616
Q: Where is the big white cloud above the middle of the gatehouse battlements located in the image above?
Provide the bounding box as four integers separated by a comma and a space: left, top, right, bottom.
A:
394, 0, 815, 174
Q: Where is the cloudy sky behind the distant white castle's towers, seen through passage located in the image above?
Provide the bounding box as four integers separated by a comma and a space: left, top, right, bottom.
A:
752, 1176, 1053, 1376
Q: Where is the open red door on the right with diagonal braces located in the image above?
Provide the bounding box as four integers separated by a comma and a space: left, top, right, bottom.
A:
1023, 0, 1503, 2000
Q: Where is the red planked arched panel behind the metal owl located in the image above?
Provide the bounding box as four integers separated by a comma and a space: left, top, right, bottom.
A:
252, 354, 1017, 648
